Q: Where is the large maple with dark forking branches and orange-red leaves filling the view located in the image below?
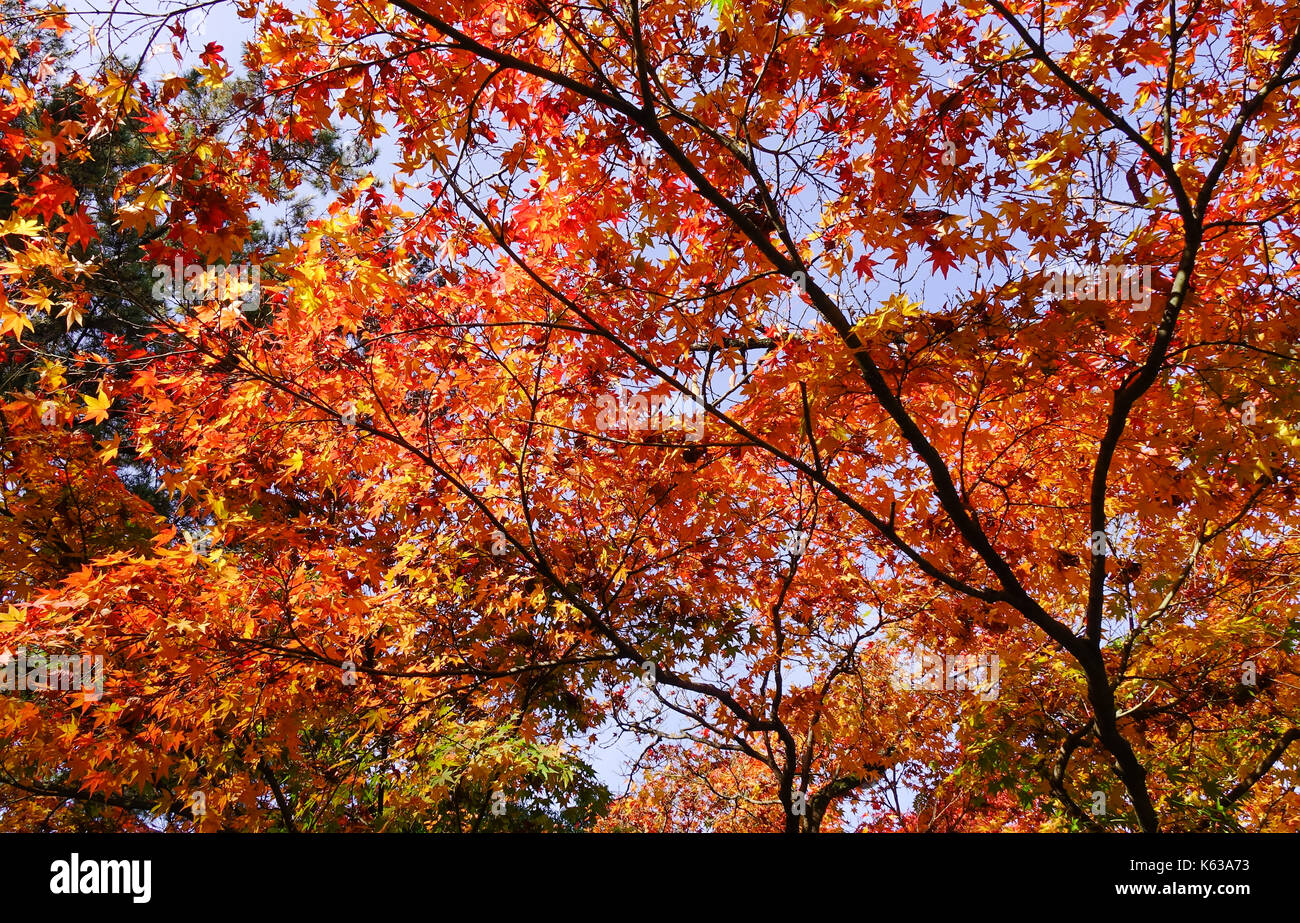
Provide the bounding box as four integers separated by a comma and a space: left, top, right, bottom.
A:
0, 0, 1300, 832
